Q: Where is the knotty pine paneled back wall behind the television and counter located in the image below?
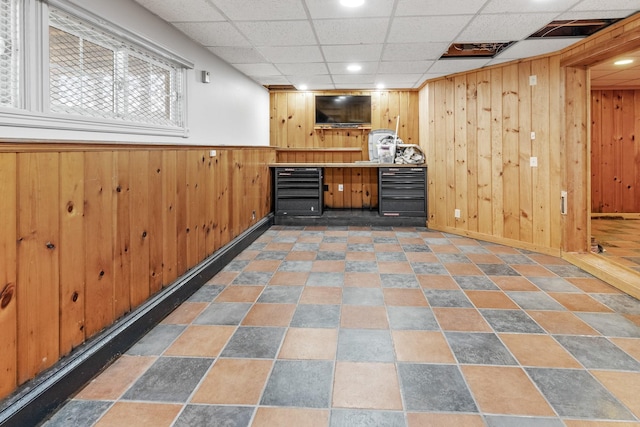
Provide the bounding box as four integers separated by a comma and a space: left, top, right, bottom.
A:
271, 91, 419, 209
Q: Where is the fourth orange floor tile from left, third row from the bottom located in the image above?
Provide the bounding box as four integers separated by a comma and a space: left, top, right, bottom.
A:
500, 334, 581, 369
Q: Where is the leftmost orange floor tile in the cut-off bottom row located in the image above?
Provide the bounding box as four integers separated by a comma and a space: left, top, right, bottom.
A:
91, 402, 182, 427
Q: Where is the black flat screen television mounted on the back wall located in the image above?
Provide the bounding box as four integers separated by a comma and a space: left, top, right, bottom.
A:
316, 95, 371, 127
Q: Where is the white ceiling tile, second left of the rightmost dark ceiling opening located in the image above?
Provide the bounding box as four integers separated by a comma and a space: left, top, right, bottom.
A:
387, 15, 473, 43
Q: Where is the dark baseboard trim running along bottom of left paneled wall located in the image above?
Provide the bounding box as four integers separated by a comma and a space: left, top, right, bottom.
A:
0, 214, 273, 427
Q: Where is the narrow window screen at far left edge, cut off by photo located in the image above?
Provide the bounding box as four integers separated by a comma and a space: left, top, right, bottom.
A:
0, 0, 20, 107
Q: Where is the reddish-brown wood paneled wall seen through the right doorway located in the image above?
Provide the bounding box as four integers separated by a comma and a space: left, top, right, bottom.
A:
591, 90, 640, 213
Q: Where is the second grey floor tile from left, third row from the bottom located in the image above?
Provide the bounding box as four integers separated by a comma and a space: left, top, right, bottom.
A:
220, 326, 285, 359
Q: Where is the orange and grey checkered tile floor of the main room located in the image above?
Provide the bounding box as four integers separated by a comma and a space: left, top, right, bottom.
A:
45, 226, 640, 427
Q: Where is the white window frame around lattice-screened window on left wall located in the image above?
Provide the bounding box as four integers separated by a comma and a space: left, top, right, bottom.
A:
0, 0, 193, 137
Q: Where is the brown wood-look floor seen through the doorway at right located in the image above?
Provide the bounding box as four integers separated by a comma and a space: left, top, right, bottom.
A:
591, 218, 640, 273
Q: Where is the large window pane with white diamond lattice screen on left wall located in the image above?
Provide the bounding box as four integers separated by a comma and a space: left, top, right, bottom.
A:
49, 9, 183, 127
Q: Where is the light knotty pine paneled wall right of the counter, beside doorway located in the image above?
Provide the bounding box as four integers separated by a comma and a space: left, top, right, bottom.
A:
420, 55, 562, 252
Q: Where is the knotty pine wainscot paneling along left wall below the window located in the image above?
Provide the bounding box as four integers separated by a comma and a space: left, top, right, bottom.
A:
0, 143, 275, 398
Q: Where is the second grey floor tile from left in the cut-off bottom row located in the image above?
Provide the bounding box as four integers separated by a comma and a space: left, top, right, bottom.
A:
173, 405, 254, 427
